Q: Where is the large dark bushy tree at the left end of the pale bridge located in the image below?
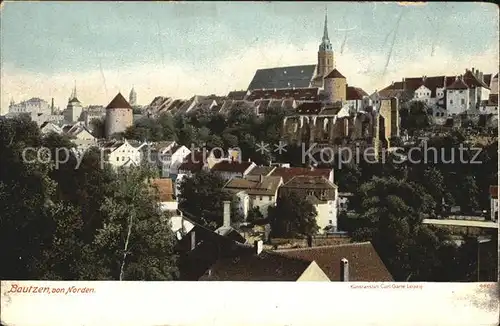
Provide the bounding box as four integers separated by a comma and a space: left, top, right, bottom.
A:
352, 177, 435, 280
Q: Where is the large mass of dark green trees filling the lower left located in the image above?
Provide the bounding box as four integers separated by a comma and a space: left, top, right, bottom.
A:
0, 118, 177, 280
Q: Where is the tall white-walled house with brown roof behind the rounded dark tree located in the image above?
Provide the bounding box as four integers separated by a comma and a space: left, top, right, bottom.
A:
278, 176, 338, 232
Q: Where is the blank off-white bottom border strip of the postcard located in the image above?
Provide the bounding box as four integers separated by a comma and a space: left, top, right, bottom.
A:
1, 281, 499, 326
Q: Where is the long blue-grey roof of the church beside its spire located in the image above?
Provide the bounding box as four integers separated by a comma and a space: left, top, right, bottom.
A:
248, 65, 316, 90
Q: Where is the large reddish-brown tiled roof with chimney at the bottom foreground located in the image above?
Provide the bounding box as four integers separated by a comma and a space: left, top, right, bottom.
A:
277, 242, 394, 282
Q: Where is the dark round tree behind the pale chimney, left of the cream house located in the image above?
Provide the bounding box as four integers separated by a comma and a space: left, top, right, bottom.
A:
178, 171, 241, 229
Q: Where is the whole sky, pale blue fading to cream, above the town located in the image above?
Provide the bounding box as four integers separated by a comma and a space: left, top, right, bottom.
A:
0, 2, 499, 113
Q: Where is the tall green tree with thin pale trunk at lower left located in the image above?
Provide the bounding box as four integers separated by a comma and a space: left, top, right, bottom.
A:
92, 168, 177, 281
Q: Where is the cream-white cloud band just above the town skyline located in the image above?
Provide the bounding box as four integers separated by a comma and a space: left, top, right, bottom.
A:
0, 43, 498, 114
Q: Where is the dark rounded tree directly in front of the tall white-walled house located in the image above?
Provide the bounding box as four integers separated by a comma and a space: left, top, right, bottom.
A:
269, 192, 319, 237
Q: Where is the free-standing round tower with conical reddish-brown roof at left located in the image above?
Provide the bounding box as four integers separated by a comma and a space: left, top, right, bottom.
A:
105, 93, 133, 138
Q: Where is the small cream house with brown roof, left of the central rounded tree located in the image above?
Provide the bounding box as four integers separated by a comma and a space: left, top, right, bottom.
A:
224, 175, 283, 219
